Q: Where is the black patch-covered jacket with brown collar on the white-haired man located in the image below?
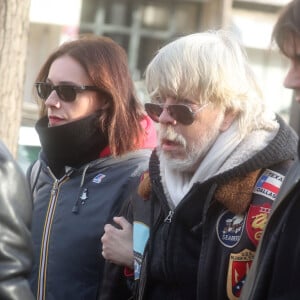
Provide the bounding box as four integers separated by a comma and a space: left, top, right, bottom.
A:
100, 116, 297, 300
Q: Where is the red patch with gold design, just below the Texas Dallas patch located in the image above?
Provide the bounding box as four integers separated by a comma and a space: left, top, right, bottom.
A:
246, 203, 271, 246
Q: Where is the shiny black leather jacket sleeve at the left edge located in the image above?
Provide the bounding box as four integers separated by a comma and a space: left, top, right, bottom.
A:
0, 142, 34, 300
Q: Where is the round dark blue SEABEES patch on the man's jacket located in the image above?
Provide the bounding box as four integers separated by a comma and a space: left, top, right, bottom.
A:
216, 210, 245, 248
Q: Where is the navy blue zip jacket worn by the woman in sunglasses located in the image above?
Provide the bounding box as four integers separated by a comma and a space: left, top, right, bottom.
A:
30, 149, 151, 300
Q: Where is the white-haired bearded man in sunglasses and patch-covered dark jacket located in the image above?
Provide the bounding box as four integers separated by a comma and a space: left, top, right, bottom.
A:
100, 30, 297, 300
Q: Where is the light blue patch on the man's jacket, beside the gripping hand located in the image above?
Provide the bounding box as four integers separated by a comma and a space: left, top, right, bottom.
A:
133, 222, 149, 280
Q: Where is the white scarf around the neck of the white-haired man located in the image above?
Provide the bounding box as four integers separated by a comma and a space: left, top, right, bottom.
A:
160, 122, 242, 207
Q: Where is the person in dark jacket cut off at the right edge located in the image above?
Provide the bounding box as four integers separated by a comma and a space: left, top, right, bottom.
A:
242, 0, 300, 300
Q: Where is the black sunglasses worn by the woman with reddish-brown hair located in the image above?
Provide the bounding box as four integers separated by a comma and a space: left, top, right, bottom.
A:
35, 82, 100, 102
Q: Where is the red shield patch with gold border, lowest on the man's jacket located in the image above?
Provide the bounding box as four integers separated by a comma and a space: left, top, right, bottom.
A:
227, 249, 255, 300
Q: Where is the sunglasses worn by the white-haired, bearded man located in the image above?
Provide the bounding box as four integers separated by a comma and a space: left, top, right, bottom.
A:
145, 103, 208, 125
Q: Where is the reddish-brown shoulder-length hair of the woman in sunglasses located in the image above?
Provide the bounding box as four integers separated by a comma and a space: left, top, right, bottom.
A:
36, 35, 144, 155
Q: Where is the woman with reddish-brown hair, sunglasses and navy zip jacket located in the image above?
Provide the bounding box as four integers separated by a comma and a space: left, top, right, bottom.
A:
28, 35, 156, 300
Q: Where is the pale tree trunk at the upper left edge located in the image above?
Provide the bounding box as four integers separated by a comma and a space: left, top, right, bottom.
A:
0, 0, 30, 156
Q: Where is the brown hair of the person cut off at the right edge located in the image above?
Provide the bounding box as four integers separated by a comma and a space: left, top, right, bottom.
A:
272, 0, 300, 54
